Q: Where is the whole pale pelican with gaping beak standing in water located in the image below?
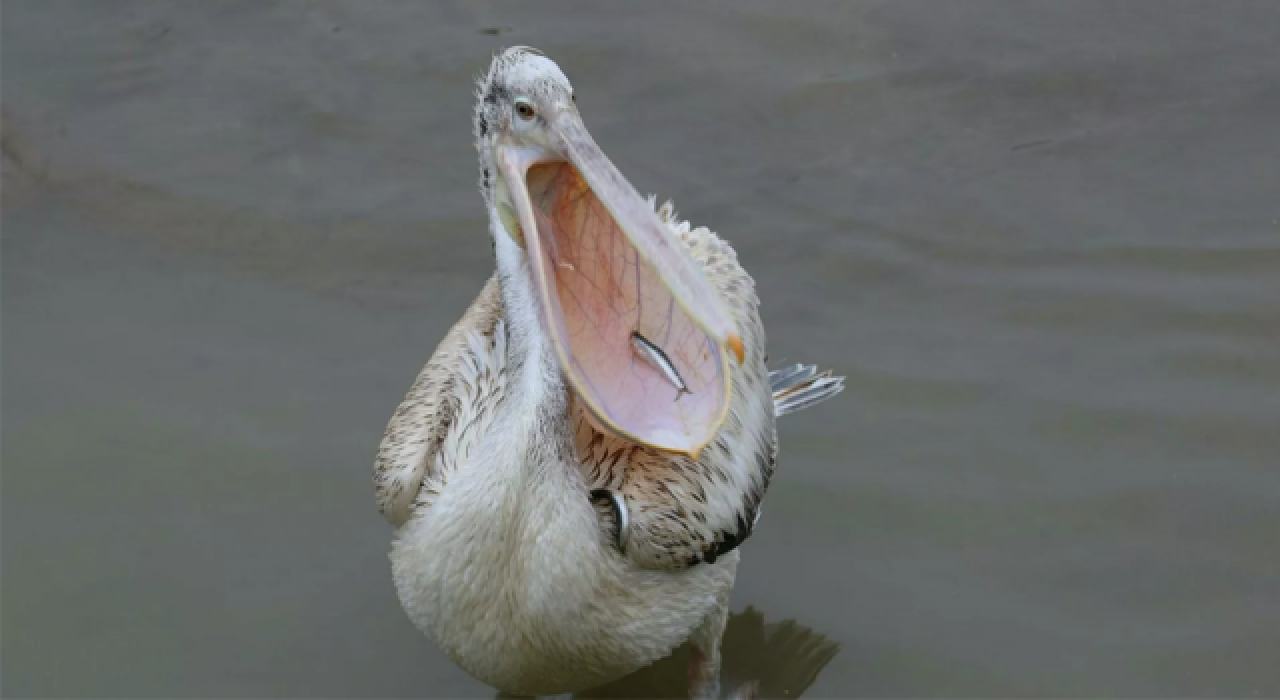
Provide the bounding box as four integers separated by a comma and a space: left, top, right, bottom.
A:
374, 46, 842, 696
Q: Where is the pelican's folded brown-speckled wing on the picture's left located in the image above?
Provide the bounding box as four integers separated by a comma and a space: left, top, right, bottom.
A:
374, 275, 504, 526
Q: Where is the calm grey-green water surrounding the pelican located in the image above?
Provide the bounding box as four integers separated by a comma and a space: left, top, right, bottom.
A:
3, 0, 1280, 696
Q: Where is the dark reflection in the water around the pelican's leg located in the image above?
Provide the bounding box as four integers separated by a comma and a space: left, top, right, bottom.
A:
560, 607, 840, 697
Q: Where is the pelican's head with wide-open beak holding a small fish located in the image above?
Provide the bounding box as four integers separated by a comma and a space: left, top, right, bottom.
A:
475, 47, 744, 454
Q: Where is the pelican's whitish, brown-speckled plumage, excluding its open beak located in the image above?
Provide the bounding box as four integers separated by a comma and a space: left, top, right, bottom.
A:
374, 47, 841, 695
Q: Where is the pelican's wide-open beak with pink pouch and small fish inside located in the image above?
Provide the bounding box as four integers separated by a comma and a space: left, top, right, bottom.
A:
495, 106, 744, 456
